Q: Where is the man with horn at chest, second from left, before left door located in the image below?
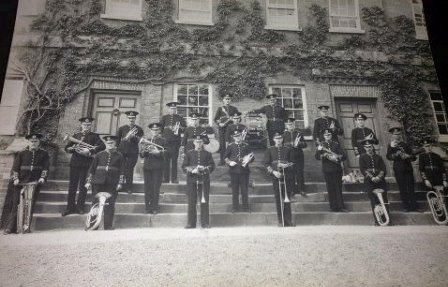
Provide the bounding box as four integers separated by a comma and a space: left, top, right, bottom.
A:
62, 117, 105, 216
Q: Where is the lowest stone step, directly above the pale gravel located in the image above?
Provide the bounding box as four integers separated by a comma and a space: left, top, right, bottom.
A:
32, 212, 435, 231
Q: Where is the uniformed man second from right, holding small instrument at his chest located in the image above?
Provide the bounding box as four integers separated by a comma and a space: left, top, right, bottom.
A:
386, 127, 421, 212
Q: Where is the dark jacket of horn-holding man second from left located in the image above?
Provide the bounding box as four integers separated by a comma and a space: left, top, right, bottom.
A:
65, 132, 106, 167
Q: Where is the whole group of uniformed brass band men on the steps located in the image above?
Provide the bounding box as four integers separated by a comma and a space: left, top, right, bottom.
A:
4, 94, 448, 234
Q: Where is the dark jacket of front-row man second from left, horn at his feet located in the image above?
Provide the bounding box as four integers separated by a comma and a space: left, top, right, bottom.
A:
87, 150, 124, 185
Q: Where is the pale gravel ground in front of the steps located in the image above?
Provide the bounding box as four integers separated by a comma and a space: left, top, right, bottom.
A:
0, 226, 448, 287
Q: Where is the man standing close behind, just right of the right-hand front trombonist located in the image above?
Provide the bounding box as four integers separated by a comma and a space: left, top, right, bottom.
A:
283, 118, 307, 196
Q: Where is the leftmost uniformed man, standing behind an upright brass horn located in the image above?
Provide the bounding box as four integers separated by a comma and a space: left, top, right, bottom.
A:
4, 133, 50, 234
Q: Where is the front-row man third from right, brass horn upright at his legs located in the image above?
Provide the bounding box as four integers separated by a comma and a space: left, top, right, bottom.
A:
359, 140, 391, 225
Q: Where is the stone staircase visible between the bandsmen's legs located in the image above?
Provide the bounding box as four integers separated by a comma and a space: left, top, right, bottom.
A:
28, 180, 435, 231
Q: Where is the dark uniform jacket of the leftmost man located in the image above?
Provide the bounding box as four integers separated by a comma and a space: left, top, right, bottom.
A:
12, 148, 50, 183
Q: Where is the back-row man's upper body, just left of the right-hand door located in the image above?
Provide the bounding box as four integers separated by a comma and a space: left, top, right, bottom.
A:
313, 105, 344, 145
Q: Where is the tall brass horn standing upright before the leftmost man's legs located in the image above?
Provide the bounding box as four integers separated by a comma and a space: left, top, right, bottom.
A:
17, 181, 38, 233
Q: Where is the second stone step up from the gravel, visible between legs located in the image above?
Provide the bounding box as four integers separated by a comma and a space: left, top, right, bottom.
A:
34, 201, 429, 214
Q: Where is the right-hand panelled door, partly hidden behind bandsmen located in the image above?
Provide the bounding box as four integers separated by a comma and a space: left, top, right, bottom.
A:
335, 99, 384, 169
